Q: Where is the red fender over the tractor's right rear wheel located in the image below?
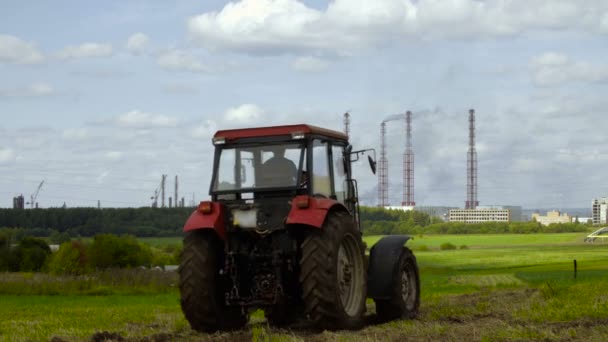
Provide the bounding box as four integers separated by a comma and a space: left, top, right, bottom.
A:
285, 195, 348, 228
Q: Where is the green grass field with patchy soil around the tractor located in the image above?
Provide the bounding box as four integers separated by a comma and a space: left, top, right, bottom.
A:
0, 234, 608, 341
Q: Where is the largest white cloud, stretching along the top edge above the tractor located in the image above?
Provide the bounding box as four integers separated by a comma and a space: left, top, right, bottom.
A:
188, 0, 608, 54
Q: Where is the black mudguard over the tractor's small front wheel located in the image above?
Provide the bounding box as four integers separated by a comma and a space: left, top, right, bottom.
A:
367, 235, 410, 299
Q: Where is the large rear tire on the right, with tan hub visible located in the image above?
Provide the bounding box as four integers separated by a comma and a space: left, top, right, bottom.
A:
300, 212, 367, 329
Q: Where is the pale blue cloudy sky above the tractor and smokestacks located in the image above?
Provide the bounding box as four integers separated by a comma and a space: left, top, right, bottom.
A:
0, 0, 608, 209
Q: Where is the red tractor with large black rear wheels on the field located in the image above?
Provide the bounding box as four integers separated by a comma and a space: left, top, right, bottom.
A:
179, 125, 420, 332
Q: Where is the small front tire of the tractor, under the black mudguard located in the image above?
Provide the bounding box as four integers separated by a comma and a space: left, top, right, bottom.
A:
374, 247, 420, 322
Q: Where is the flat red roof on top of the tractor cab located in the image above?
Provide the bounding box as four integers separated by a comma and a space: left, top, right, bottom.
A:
213, 124, 348, 141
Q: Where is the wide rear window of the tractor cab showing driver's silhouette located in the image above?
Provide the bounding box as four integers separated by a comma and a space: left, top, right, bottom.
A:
212, 143, 304, 191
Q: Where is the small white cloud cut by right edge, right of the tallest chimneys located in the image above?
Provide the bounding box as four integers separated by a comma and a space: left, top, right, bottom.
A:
530, 52, 608, 87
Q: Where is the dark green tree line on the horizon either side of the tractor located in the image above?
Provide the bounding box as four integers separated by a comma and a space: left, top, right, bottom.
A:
0, 207, 588, 239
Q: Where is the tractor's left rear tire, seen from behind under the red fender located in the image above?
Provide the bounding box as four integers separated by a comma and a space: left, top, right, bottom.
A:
179, 231, 247, 333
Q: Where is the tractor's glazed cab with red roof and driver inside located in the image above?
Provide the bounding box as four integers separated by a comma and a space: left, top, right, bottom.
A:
204, 125, 366, 230
